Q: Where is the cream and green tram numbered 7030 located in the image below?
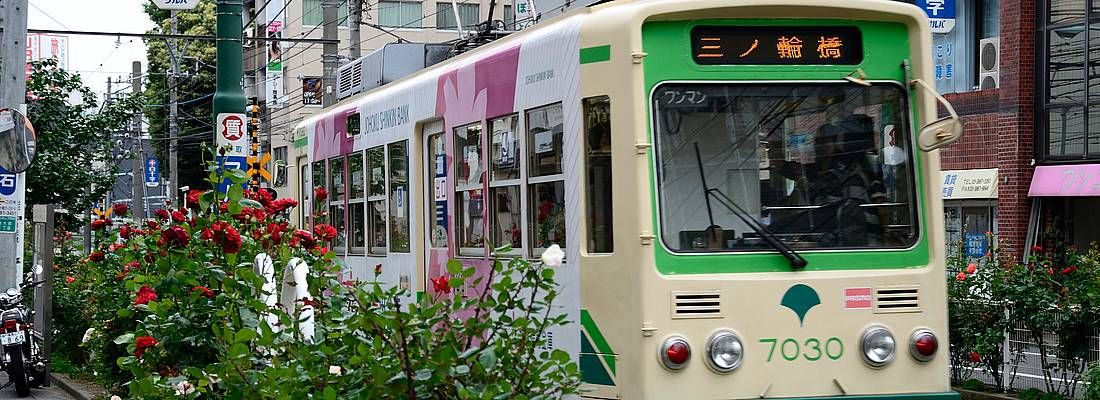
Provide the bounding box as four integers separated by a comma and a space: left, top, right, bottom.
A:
292, 0, 961, 399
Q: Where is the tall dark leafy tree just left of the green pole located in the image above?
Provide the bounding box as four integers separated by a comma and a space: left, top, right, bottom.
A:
144, 1, 217, 188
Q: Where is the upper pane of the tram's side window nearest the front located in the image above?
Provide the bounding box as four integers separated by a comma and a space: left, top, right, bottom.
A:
527, 103, 562, 177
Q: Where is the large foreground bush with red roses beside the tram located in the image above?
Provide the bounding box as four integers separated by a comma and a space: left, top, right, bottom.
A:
54, 154, 579, 399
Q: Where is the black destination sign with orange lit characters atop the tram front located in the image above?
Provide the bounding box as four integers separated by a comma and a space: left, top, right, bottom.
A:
691, 26, 864, 65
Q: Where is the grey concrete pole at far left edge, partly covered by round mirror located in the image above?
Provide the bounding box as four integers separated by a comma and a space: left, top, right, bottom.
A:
0, 0, 28, 289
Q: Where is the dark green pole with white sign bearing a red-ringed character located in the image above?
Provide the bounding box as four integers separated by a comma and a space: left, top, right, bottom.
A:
212, 0, 249, 184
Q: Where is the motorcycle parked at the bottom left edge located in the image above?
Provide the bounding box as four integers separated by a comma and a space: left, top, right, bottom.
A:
0, 266, 50, 397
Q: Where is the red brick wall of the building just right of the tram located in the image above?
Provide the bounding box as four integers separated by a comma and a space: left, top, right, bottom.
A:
941, 0, 1037, 258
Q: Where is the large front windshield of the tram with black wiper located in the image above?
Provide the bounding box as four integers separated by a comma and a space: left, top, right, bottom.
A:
652, 81, 917, 252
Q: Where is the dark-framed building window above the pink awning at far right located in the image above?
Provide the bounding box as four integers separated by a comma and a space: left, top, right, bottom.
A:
1036, 0, 1100, 160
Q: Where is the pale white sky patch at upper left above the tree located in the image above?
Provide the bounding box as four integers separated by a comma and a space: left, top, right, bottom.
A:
26, 0, 154, 101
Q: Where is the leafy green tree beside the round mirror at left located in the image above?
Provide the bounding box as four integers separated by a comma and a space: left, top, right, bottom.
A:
26, 59, 141, 215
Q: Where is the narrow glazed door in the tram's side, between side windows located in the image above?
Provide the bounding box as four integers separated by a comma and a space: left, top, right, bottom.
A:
421, 121, 448, 290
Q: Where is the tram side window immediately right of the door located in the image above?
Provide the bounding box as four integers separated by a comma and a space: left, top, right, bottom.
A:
454, 123, 485, 256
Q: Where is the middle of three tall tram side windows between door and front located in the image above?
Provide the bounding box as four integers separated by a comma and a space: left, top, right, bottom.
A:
488, 115, 524, 255
